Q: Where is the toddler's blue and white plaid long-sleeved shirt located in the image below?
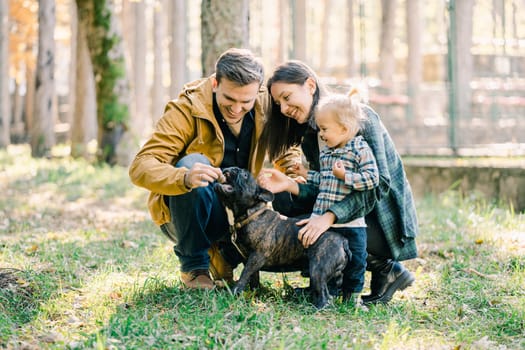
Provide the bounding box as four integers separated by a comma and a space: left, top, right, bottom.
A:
307, 136, 379, 219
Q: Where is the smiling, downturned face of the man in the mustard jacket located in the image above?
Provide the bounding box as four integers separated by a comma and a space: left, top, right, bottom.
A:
213, 78, 259, 124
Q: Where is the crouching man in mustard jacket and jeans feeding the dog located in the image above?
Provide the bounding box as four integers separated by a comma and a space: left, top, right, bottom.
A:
129, 49, 268, 289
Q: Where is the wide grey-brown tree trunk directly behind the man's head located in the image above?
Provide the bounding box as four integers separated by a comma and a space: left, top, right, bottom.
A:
201, 0, 249, 76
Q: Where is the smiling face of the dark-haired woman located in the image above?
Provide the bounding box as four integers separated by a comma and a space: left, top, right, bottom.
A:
270, 78, 316, 124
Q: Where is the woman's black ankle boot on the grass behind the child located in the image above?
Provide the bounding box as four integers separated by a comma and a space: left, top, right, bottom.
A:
361, 254, 415, 304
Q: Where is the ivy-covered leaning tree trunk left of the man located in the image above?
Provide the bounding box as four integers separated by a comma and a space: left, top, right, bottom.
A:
77, 0, 130, 165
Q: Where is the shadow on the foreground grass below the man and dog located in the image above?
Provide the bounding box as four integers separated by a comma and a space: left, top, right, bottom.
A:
78, 278, 315, 349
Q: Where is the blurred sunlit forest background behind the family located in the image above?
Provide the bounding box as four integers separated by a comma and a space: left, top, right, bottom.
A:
0, 0, 525, 165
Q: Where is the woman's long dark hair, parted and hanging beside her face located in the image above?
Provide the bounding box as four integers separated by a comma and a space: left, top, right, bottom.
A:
260, 60, 325, 161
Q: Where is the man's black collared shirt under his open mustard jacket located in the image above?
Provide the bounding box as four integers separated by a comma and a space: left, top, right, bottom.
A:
213, 94, 255, 169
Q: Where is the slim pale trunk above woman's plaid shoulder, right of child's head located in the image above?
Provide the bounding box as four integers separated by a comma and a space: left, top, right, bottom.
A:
379, 0, 397, 93
